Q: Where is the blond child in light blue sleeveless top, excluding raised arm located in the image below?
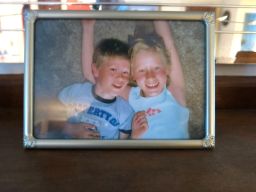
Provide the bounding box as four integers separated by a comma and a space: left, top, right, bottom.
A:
128, 33, 189, 139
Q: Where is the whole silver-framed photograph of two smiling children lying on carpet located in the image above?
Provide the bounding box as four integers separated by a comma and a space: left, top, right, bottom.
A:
24, 10, 215, 149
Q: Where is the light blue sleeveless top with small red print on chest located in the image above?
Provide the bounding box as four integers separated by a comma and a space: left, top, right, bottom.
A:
129, 87, 189, 139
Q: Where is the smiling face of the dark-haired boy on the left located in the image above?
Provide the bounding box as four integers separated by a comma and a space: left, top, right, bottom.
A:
92, 56, 130, 99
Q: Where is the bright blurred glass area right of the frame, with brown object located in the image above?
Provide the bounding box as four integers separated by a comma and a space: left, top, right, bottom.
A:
216, 8, 256, 64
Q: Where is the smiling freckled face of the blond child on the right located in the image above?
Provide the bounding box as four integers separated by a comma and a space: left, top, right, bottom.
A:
132, 50, 168, 97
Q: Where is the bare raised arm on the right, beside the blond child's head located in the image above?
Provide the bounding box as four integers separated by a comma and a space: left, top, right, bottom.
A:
154, 21, 186, 106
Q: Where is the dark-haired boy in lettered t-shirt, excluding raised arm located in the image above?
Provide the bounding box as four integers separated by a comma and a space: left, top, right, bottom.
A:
59, 36, 134, 139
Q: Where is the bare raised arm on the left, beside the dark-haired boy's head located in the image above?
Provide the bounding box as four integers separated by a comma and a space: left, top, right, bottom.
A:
82, 20, 95, 83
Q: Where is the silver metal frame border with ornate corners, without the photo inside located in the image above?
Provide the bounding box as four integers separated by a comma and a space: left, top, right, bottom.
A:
24, 11, 215, 149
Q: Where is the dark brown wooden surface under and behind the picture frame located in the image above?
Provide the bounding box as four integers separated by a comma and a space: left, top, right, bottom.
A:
0, 75, 256, 192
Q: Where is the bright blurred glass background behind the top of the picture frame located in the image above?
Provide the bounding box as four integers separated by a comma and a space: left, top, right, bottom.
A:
0, 0, 256, 67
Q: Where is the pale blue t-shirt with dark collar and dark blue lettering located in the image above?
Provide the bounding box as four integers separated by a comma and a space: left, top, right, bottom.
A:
59, 82, 134, 139
